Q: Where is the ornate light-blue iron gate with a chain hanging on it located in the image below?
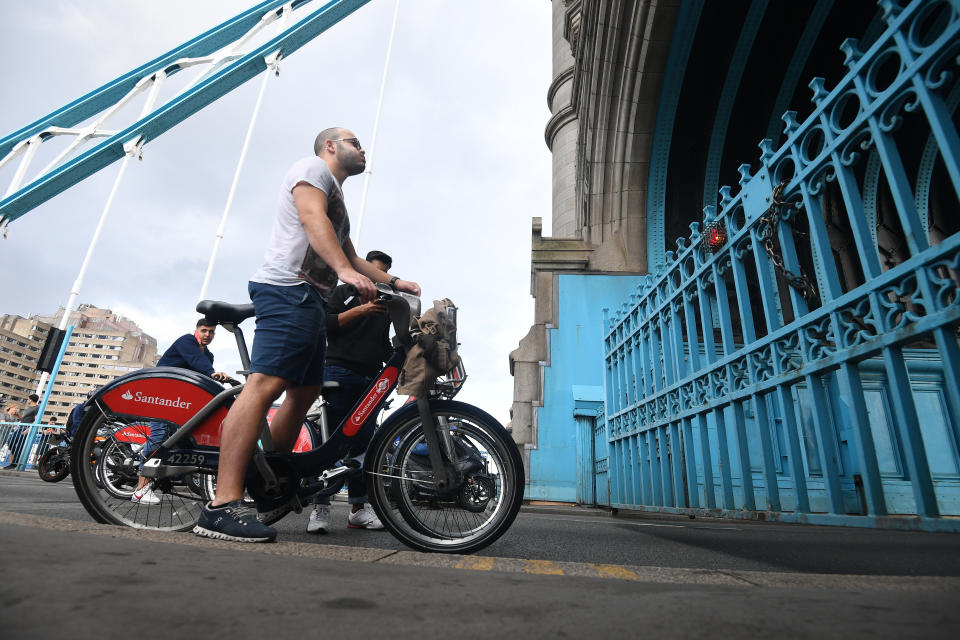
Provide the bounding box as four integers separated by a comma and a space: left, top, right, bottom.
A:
597, 0, 960, 531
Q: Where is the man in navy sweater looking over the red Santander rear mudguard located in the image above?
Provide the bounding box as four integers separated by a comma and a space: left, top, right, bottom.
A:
130, 318, 230, 504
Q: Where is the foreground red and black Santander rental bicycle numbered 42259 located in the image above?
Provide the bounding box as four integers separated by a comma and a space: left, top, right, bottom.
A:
70, 285, 524, 553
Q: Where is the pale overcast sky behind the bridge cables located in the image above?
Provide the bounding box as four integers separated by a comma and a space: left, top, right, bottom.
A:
0, 0, 551, 430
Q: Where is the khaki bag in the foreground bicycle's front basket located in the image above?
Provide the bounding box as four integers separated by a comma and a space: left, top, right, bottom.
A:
397, 298, 460, 396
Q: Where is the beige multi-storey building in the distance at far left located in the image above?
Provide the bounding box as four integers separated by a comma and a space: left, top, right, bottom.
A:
0, 304, 158, 424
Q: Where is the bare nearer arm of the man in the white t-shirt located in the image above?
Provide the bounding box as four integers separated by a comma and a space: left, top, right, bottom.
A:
293, 182, 377, 302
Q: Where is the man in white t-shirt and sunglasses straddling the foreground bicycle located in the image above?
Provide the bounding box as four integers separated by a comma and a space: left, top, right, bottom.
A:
193, 127, 420, 542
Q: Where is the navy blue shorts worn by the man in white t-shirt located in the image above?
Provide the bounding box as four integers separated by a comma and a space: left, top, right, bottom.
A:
247, 282, 327, 387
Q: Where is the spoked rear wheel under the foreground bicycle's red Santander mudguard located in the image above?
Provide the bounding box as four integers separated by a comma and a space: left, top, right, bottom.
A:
70, 407, 207, 531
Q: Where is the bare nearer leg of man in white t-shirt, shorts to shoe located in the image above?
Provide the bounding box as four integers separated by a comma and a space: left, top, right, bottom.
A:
211, 373, 289, 506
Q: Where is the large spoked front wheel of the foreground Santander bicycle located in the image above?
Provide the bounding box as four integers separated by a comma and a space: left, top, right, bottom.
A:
364, 400, 524, 553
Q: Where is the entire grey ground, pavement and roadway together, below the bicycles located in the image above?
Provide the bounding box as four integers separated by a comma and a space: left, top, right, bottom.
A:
0, 472, 960, 639
